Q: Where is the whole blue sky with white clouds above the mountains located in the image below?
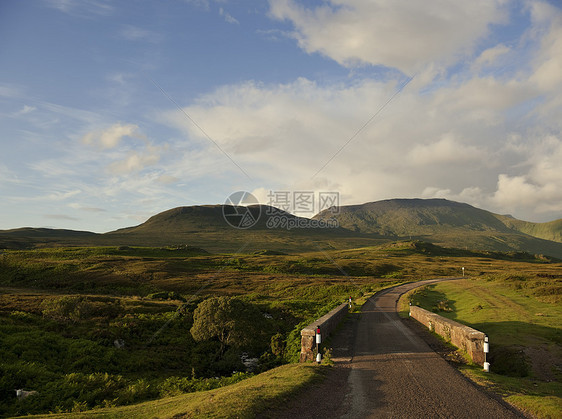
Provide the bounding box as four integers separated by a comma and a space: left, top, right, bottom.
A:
0, 0, 562, 232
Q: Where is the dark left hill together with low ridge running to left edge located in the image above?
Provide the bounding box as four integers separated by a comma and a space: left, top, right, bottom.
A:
0, 205, 376, 253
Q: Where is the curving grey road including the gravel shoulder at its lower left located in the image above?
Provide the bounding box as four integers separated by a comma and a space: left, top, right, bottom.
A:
266, 278, 524, 419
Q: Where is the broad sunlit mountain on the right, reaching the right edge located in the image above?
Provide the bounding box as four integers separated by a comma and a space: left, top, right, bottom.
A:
314, 199, 562, 258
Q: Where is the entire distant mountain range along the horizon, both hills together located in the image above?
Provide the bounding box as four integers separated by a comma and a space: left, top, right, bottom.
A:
0, 199, 562, 259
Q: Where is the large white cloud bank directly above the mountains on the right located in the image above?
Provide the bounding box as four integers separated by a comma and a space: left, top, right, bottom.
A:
159, 39, 562, 220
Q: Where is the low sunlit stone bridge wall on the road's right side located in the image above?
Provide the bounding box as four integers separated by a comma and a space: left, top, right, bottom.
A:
410, 306, 486, 365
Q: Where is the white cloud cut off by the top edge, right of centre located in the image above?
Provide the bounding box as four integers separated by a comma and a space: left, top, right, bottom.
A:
270, 0, 507, 74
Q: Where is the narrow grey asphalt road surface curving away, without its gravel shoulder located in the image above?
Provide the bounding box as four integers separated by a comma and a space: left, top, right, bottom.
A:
331, 280, 521, 419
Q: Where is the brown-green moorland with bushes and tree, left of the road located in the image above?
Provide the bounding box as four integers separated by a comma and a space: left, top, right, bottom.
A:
0, 248, 393, 416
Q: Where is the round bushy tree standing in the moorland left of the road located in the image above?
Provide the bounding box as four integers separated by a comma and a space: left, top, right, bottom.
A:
191, 297, 265, 353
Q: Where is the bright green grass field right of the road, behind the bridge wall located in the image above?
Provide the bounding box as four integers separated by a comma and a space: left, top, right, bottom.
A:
403, 272, 562, 418
